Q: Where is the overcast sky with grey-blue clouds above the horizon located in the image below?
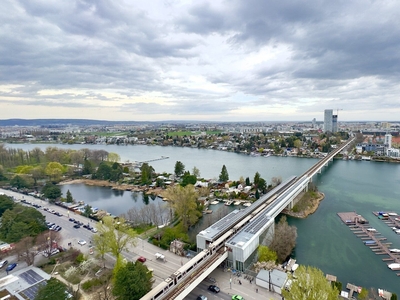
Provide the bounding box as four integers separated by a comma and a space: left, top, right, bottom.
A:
0, 0, 400, 121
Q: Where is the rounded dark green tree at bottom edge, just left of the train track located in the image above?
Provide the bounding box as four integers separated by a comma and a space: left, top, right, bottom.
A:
113, 261, 153, 300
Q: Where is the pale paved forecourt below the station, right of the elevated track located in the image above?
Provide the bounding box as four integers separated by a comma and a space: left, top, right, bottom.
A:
207, 268, 283, 300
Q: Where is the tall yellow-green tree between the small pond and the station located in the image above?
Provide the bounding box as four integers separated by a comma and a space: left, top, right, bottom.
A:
163, 184, 201, 230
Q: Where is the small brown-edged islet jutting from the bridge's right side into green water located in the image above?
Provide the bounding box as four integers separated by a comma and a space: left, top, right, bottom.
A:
282, 191, 325, 219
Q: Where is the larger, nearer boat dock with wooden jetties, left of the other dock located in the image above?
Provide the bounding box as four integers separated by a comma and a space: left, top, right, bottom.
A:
338, 212, 400, 276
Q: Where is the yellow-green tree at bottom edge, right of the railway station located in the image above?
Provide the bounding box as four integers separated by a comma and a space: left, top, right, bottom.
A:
282, 266, 339, 300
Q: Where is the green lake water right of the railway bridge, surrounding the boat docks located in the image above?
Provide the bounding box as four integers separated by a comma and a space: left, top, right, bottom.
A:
289, 160, 400, 295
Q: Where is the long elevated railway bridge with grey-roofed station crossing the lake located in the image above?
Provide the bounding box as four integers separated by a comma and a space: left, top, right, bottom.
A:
141, 138, 354, 300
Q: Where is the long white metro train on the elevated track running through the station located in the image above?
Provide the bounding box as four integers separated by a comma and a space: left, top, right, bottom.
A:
141, 176, 297, 300
